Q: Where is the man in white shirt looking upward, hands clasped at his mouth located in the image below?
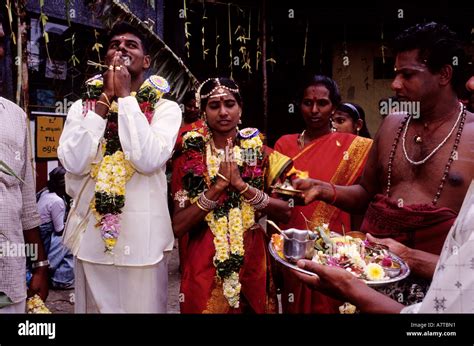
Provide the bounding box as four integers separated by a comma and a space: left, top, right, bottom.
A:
58, 23, 181, 313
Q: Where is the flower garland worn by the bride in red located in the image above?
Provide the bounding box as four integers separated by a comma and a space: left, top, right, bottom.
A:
177, 128, 264, 308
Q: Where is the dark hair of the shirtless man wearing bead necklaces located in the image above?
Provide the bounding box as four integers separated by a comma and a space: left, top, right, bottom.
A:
393, 22, 466, 92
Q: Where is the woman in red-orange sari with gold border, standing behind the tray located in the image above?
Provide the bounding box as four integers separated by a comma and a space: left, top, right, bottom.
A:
275, 76, 372, 313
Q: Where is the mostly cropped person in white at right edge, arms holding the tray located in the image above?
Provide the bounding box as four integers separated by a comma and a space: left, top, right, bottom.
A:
295, 76, 474, 313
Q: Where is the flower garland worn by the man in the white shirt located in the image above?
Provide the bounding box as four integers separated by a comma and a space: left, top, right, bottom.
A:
83, 75, 169, 254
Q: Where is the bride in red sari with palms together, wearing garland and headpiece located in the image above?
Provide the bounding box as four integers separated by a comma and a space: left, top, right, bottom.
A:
172, 78, 291, 313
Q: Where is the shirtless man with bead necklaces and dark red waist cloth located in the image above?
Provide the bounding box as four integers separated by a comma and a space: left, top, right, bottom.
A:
294, 23, 474, 302
